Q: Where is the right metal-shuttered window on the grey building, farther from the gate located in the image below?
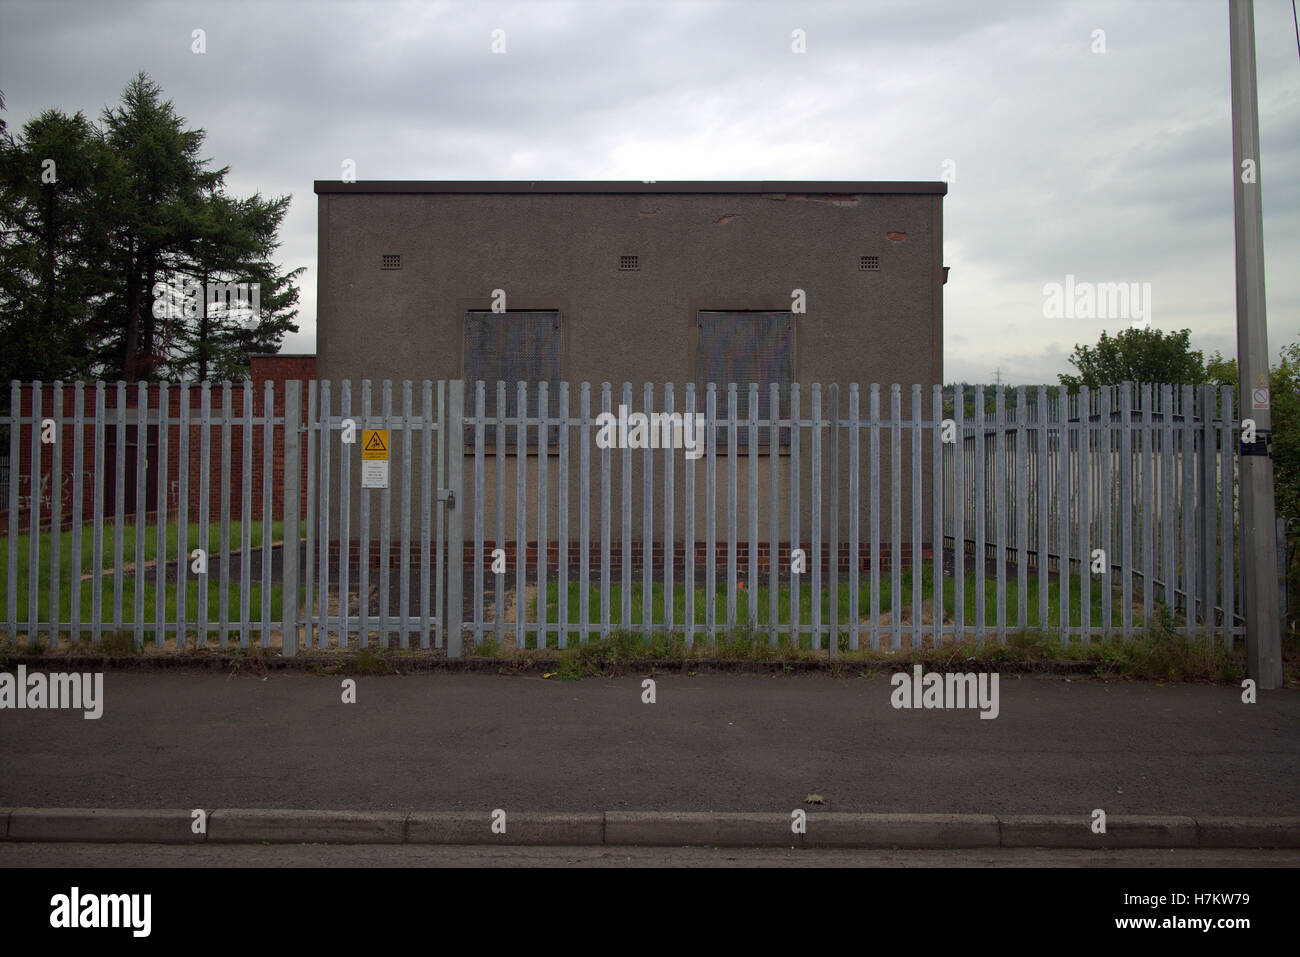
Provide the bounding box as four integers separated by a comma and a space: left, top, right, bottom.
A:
696, 309, 794, 447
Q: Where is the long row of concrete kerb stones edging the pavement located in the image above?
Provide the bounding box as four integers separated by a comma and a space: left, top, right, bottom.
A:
0, 807, 1300, 849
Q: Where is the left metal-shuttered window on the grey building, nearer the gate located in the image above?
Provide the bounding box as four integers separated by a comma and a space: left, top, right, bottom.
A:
464, 309, 560, 449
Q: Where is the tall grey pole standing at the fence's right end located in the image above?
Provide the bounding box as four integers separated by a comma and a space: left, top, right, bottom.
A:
1229, 0, 1282, 689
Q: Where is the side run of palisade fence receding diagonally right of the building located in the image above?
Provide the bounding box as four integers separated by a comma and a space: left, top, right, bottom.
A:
944, 384, 1244, 641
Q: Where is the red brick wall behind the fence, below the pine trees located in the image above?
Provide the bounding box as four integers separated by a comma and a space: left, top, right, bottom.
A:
0, 355, 316, 529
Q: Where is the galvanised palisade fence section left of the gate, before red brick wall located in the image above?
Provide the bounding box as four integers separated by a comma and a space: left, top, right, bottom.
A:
0, 382, 309, 653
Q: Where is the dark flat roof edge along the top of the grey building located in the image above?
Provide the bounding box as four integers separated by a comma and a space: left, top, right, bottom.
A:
313, 179, 948, 195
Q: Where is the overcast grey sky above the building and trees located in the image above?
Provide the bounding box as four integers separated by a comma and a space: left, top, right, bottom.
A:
0, 0, 1300, 384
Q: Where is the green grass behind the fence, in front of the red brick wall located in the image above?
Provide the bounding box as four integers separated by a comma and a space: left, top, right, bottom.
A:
0, 521, 289, 636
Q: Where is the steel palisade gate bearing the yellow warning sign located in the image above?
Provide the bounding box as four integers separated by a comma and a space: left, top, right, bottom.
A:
301, 380, 454, 657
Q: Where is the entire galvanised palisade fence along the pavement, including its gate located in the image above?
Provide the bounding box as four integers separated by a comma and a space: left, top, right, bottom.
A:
0, 381, 1244, 657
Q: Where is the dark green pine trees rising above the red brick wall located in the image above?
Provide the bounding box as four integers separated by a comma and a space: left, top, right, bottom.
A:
0, 73, 304, 381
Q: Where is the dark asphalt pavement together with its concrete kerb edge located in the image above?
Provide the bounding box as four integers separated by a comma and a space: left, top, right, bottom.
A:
0, 666, 1300, 850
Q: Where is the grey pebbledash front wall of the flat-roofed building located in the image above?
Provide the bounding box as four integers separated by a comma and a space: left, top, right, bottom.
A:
316, 181, 948, 553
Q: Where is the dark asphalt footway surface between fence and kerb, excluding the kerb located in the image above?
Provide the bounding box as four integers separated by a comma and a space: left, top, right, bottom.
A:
0, 672, 1300, 815
